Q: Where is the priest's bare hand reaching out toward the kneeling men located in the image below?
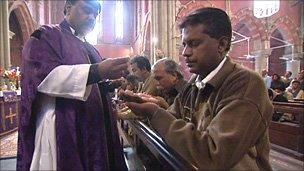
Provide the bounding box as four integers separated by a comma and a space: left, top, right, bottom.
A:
98, 57, 130, 79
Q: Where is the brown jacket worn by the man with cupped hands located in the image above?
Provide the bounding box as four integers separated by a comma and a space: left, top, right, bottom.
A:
151, 58, 273, 170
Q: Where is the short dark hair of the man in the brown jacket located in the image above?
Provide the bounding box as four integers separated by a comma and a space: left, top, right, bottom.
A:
179, 7, 232, 51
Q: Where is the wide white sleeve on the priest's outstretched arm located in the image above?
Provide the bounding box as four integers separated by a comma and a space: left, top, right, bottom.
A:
38, 64, 92, 101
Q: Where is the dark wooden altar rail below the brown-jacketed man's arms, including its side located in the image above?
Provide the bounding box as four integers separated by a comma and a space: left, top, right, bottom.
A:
120, 120, 197, 170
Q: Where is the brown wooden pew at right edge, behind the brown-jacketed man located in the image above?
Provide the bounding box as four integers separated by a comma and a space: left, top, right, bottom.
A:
269, 102, 304, 160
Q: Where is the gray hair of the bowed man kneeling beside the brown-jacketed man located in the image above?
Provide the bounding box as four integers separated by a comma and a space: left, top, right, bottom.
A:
153, 58, 184, 80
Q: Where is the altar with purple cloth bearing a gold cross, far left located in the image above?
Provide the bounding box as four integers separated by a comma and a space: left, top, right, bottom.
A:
0, 91, 21, 137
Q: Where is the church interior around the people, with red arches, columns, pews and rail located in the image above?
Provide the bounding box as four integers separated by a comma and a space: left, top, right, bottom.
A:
0, 0, 304, 170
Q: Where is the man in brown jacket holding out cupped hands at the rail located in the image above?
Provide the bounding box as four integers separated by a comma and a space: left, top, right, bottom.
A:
122, 8, 273, 170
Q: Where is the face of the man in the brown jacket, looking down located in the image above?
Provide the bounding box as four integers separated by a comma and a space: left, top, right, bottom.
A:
182, 24, 226, 77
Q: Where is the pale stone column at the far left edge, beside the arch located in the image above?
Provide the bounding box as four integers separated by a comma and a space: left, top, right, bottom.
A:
0, 1, 10, 69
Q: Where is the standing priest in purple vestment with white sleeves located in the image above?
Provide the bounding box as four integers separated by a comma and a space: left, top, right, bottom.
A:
17, 0, 129, 170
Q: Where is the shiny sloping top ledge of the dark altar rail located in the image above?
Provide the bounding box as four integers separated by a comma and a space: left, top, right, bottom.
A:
123, 120, 197, 170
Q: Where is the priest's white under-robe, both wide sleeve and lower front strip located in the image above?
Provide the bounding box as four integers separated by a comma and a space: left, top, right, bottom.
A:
30, 64, 92, 170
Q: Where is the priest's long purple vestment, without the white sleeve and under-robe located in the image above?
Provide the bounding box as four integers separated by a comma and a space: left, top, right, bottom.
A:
17, 21, 127, 171
